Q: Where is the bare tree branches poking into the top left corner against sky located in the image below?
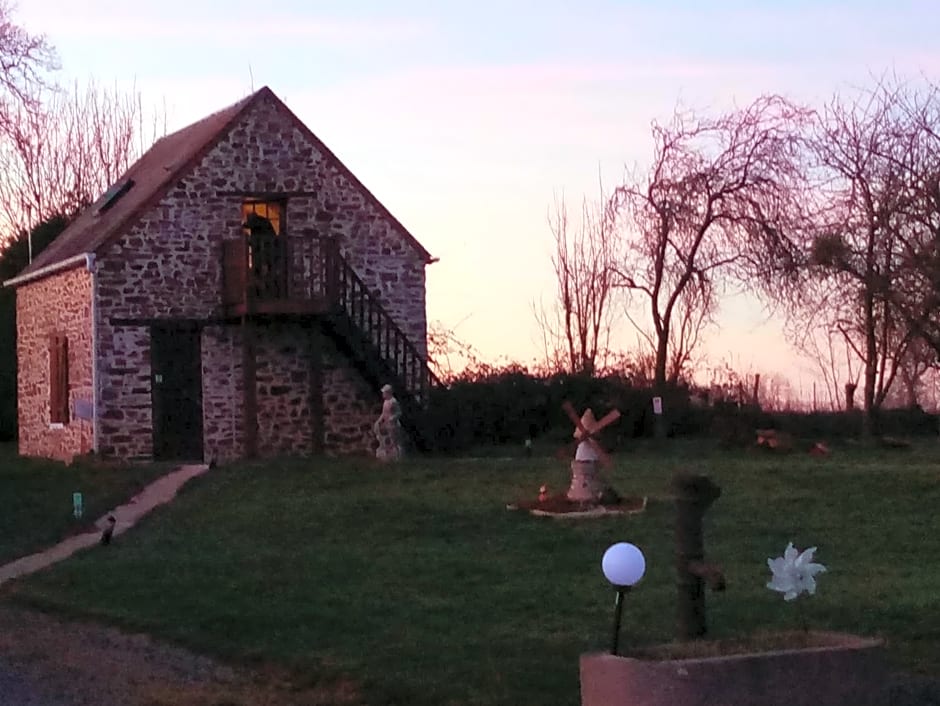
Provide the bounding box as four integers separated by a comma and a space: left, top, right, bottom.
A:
0, 0, 58, 130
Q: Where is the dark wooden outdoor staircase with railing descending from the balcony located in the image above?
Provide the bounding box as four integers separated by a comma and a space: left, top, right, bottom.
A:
323, 240, 445, 451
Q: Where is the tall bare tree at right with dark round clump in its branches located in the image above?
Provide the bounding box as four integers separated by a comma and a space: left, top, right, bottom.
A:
810, 78, 940, 435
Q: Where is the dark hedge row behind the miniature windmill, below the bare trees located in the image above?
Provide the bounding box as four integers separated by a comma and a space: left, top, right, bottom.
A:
420, 369, 940, 452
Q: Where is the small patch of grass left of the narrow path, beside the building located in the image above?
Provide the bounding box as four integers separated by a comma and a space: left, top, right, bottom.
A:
0, 444, 168, 564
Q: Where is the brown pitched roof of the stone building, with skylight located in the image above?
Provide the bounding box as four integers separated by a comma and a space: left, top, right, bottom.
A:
11, 86, 434, 283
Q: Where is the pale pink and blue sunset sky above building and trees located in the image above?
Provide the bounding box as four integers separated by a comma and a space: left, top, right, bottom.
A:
15, 0, 940, 402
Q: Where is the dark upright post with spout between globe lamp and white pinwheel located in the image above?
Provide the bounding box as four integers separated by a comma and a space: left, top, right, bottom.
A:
672, 472, 725, 640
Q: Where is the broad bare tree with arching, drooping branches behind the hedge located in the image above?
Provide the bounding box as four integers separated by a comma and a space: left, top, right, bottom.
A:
609, 96, 807, 433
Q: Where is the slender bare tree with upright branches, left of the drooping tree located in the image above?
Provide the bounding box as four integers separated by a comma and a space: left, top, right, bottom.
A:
533, 184, 614, 375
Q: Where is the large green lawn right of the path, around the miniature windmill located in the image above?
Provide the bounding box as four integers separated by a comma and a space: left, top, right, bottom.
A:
7, 443, 940, 706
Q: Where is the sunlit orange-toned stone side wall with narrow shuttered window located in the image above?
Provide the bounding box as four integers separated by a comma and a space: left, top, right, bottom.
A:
16, 267, 94, 461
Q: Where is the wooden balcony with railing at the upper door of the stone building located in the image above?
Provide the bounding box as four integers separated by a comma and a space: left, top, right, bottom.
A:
222, 233, 335, 316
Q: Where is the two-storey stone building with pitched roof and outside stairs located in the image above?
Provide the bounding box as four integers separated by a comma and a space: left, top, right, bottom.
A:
4, 87, 436, 462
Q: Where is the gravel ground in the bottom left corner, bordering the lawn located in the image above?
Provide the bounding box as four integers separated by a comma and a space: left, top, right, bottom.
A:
0, 602, 359, 706
